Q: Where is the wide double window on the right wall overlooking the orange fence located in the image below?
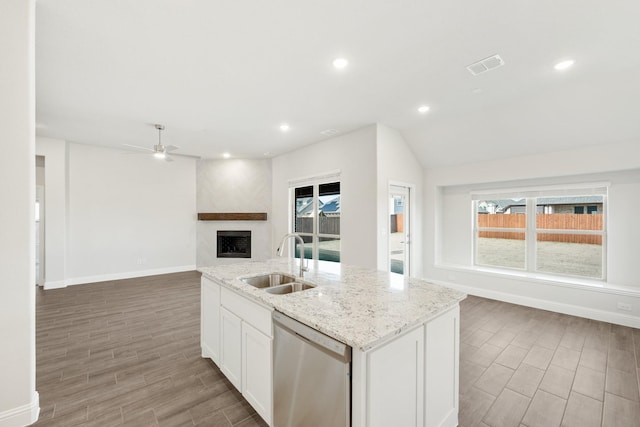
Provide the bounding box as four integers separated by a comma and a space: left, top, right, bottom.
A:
473, 188, 606, 279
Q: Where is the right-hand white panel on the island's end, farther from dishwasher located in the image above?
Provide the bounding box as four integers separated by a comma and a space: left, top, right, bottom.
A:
425, 307, 460, 427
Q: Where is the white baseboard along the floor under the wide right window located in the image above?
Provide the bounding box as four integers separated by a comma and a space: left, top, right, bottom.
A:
429, 280, 640, 328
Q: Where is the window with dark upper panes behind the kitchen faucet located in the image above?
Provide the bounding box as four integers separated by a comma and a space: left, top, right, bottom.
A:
292, 181, 341, 262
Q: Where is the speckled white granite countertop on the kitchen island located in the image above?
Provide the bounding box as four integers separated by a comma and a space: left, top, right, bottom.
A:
198, 258, 466, 351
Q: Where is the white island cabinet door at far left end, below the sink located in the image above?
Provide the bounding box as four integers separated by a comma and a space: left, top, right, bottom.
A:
200, 277, 220, 366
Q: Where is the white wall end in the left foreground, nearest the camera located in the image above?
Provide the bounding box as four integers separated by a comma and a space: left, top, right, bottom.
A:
0, 0, 39, 427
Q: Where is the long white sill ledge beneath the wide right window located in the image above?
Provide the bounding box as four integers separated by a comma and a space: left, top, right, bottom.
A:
434, 264, 640, 297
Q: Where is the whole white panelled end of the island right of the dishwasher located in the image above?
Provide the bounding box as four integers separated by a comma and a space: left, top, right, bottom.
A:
351, 305, 460, 427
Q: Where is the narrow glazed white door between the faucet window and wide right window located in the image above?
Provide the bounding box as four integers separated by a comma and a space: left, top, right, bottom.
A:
389, 185, 411, 276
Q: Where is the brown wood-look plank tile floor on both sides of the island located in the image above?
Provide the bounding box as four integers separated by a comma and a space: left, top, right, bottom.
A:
35, 272, 640, 427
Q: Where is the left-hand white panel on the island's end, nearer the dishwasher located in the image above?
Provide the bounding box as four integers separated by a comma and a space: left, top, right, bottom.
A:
366, 327, 424, 426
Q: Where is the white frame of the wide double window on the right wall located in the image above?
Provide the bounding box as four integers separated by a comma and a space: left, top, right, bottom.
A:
472, 185, 609, 282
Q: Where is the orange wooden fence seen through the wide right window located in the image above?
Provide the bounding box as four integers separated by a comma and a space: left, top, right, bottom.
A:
478, 214, 603, 245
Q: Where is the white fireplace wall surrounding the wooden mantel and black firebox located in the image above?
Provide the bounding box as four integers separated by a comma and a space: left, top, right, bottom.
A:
197, 159, 274, 267
